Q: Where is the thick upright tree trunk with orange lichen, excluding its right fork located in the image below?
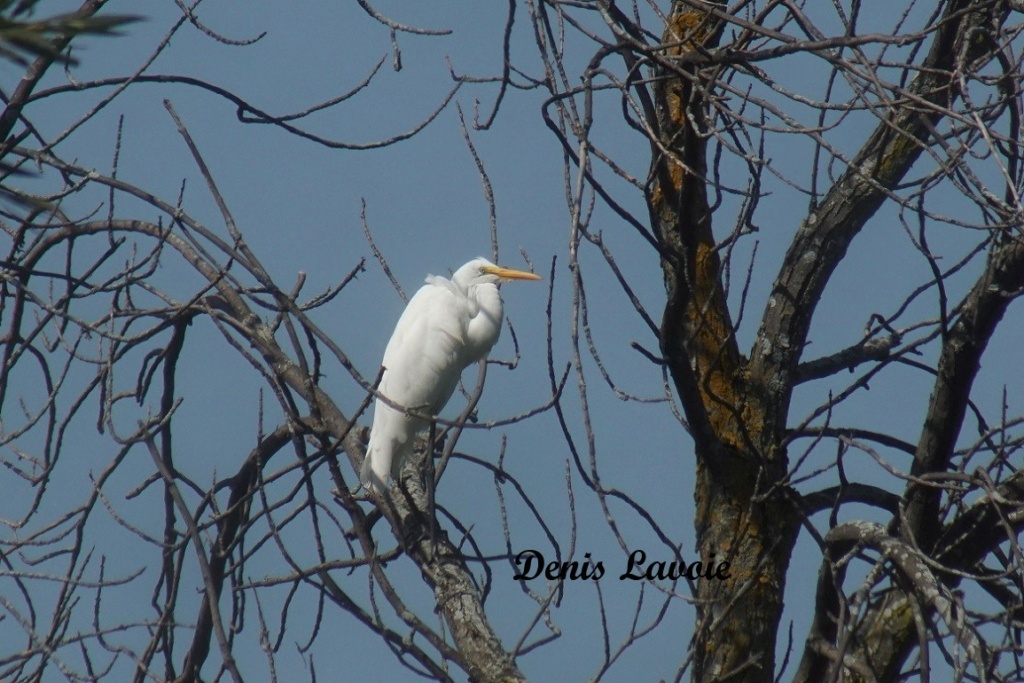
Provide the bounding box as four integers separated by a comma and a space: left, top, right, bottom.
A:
648, 2, 796, 682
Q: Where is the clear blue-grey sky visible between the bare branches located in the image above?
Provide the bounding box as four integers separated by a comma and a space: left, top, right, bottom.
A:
0, 0, 1024, 681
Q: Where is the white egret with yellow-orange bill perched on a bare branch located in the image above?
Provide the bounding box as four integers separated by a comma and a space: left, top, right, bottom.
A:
359, 258, 541, 490
